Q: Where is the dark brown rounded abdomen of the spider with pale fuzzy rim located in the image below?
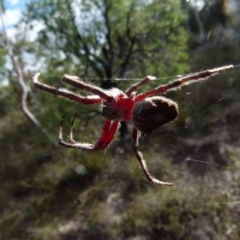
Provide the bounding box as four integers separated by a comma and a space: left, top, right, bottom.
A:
132, 97, 178, 133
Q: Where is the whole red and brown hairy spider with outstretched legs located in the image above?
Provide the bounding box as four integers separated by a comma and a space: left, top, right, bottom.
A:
33, 65, 233, 186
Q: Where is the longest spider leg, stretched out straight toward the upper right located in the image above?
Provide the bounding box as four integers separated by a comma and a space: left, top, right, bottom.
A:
135, 65, 234, 102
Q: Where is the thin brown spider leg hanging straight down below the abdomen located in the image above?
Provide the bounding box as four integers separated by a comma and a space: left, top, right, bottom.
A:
132, 128, 173, 186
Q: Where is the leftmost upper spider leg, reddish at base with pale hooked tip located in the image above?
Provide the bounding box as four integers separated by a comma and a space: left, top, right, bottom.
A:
33, 73, 102, 104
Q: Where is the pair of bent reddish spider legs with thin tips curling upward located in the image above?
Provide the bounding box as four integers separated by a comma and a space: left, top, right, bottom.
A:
59, 114, 119, 151
